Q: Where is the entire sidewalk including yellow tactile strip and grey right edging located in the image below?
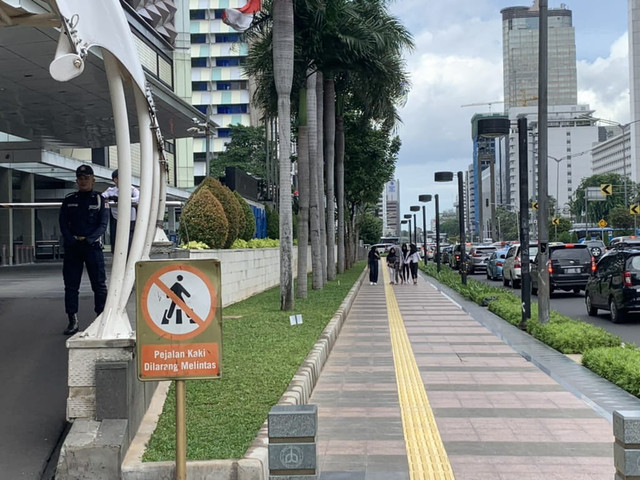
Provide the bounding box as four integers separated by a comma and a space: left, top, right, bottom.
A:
309, 268, 640, 480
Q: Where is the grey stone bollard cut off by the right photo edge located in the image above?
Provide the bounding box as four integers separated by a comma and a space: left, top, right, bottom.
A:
613, 410, 640, 480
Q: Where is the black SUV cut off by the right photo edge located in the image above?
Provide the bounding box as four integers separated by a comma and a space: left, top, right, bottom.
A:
585, 248, 640, 323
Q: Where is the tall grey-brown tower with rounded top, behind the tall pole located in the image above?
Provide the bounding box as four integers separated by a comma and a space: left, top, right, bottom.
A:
500, 1, 578, 112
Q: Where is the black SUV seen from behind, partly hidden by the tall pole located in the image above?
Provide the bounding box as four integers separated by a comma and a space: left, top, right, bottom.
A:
531, 243, 595, 295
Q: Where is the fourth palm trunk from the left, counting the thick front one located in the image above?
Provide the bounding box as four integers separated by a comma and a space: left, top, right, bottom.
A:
323, 75, 336, 280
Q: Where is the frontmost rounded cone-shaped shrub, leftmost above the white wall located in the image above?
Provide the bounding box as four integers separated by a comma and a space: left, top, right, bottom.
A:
180, 189, 229, 248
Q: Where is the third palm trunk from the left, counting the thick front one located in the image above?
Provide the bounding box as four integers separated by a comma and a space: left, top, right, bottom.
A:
307, 72, 322, 290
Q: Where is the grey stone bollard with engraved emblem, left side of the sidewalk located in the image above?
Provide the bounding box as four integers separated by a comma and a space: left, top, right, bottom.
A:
269, 405, 318, 480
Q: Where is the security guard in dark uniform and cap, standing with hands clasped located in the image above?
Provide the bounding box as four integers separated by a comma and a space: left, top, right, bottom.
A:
60, 165, 109, 335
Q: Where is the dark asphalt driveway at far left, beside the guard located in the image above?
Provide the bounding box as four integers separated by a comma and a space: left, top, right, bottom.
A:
0, 262, 108, 480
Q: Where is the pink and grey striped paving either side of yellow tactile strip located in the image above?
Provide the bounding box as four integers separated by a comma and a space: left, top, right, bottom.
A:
310, 278, 615, 480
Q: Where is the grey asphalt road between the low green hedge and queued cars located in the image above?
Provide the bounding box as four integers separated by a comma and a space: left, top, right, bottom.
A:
469, 272, 640, 345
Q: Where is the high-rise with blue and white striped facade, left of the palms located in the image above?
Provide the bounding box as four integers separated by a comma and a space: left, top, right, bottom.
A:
190, 0, 251, 183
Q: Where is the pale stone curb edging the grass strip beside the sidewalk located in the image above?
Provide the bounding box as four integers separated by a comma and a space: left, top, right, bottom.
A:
121, 268, 367, 480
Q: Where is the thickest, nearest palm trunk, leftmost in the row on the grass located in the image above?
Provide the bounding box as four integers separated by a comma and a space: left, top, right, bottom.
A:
273, 0, 294, 310
